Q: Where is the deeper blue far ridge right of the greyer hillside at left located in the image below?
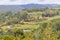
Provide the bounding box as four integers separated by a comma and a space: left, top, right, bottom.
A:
21, 4, 60, 8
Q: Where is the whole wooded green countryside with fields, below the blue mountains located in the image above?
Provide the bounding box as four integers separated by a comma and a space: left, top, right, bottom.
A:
0, 7, 60, 40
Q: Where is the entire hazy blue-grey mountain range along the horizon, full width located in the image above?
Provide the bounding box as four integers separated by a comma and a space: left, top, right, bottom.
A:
0, 4, 60, 11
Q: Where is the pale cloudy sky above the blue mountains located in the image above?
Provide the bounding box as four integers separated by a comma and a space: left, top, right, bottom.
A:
0, 0, 60, 5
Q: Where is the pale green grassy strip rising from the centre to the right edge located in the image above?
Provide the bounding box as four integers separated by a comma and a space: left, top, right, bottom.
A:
9, 16, 60, 29
